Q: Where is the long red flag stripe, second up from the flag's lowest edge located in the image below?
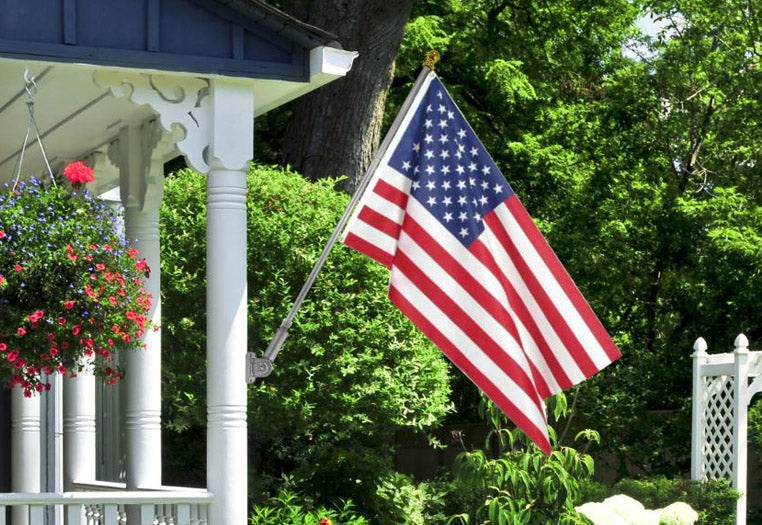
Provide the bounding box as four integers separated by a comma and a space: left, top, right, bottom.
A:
394, 248, 543, 412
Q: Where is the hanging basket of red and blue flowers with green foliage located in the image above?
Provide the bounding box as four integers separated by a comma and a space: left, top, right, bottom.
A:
0, 162, 151, 396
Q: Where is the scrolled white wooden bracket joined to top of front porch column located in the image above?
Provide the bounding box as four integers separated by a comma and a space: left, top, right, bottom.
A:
93, 70, 211, 173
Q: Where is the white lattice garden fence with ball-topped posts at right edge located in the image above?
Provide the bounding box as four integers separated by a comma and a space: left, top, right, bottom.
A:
691, 334, 762, 525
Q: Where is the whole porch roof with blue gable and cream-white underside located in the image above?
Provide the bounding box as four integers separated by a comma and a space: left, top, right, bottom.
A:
0, 0, 356, 184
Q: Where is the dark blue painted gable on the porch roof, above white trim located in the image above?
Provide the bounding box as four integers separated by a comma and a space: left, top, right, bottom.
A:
0, 0, 331, 81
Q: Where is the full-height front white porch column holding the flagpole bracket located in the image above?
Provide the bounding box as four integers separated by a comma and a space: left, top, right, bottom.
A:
206, 79, 254, 525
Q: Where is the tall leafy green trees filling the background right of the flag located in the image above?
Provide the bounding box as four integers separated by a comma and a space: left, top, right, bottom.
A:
391, 0, 762, 474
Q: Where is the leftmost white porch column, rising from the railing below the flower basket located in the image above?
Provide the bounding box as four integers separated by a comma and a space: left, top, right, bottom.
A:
11, 387, 42, 525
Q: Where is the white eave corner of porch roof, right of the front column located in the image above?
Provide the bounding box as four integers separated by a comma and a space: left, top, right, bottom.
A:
249, 46, 358, 116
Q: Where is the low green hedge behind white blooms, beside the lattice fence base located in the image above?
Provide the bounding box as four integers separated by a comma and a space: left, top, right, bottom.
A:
582, 476, 739, 525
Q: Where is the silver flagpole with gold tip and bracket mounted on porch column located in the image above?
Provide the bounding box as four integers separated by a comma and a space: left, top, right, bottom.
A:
246, 50, 439, 383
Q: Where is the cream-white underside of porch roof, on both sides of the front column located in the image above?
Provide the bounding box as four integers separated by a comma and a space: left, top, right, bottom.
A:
0, 46, 357, 187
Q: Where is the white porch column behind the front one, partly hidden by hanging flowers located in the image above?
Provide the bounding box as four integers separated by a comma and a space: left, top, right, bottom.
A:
117, 122, 164, 490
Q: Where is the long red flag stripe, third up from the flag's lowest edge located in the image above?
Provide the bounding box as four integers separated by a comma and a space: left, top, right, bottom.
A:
404, 215, 550, 398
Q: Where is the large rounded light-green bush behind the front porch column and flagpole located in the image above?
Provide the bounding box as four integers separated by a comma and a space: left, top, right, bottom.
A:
161, 166, 451, 510
